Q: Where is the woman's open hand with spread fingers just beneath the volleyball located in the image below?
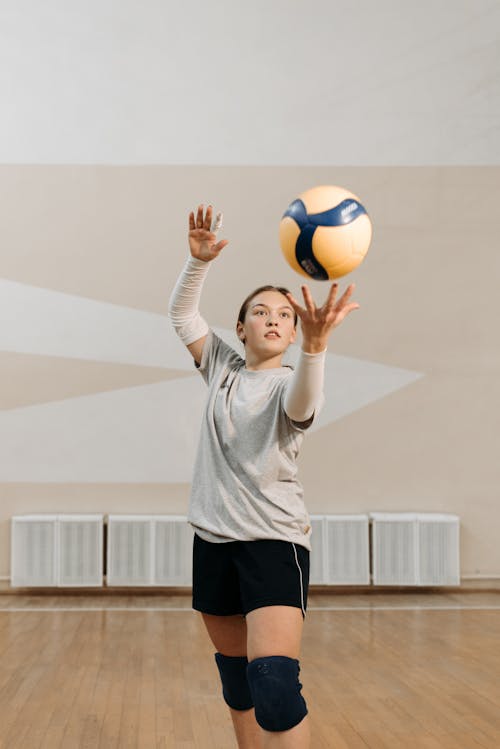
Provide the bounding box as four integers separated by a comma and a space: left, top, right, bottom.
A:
286, 283, 359, 354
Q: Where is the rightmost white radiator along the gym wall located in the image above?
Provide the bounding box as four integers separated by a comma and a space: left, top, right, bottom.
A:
370, 512, 460, 586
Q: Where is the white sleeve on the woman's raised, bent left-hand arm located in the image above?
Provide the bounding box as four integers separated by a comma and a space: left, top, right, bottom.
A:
168, 255, 210, 346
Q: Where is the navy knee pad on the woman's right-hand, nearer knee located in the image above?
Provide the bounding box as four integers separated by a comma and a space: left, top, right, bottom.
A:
247, 655, 307, 731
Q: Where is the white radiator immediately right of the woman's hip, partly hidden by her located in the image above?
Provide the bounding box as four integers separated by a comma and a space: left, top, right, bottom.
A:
310, 514, 370, 585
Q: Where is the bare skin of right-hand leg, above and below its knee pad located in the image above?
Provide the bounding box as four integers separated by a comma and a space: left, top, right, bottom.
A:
246, 606, 311, 749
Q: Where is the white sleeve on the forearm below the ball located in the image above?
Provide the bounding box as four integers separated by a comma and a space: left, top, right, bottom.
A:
283, 349, 327, 421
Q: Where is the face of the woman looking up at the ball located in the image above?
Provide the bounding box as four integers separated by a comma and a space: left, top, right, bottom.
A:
236, 291, 297, 355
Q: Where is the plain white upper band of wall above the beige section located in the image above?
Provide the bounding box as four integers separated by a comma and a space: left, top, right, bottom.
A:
0, 0, 500, 165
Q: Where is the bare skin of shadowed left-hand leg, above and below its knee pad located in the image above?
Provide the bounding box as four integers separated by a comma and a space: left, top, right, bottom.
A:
202, 614, 263, 749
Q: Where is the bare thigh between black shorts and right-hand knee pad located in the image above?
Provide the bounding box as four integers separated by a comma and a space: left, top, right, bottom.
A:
246, 606, 304, 662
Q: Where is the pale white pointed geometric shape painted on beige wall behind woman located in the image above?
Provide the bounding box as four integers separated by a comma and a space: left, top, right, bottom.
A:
0, 280, 422, 483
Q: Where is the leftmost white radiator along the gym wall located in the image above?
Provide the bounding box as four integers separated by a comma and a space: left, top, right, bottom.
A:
11, 514, 103, 588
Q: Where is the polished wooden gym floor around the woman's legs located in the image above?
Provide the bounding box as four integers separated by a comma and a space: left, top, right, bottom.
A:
0, 592, 500, 749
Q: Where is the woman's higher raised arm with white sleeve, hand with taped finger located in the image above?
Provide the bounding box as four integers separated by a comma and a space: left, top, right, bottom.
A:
168, 205, 229, 364
